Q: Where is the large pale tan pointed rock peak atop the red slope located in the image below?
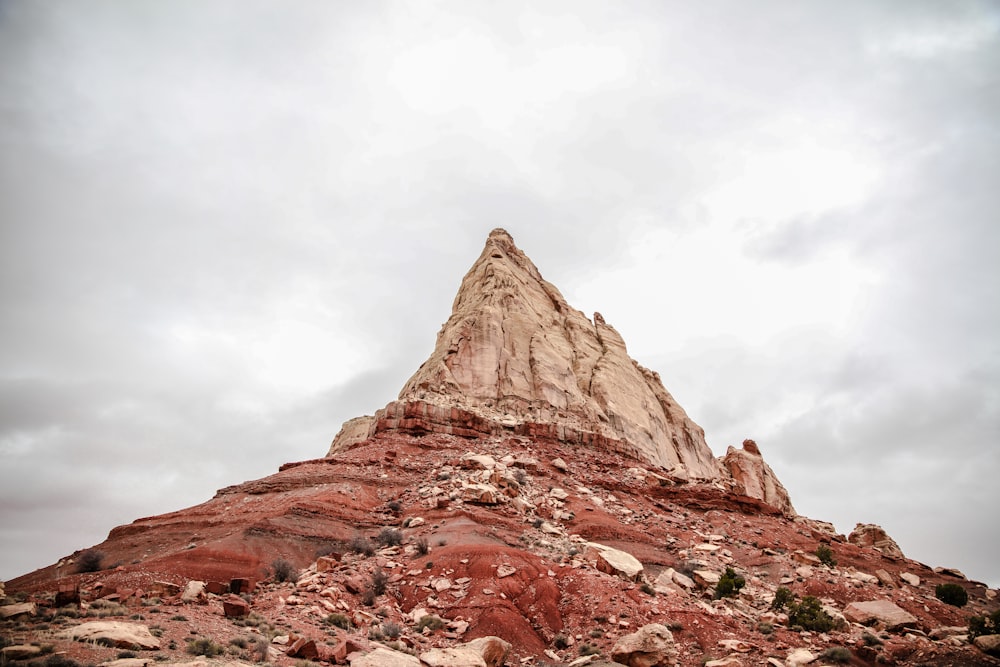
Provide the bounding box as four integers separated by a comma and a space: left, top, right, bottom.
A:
329, 229, 723, 479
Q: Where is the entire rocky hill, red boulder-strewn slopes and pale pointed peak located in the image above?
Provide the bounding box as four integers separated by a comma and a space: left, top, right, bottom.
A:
0, 230, 1000, 667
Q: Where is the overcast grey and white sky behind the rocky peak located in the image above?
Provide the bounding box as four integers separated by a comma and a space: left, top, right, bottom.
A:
0, 0, 1000, 586
